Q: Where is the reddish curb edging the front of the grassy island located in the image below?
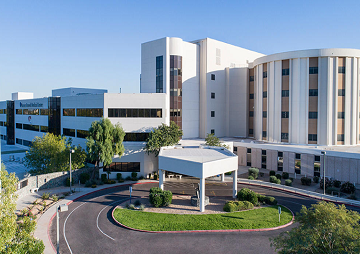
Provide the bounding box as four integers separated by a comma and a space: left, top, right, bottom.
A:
111, 201, 295, 234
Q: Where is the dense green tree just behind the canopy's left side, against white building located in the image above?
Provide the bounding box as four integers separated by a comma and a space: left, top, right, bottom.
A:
145, 121, 183, 156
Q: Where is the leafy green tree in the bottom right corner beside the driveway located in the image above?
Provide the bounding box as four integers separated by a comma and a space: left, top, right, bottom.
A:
271, 201, 360, 254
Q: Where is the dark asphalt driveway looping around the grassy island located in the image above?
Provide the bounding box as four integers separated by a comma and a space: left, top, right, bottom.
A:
50, 182, 359, 254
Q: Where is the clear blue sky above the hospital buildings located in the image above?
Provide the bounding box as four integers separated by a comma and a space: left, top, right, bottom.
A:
0, 0, 360, 100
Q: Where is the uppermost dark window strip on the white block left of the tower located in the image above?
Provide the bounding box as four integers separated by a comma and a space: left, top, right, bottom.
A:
108, 108, 162, 118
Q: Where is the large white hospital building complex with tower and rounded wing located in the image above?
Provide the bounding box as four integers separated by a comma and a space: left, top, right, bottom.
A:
0, 37, 360, 183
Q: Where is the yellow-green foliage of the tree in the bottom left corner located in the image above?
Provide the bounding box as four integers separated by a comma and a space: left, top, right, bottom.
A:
0, 164, 45, 254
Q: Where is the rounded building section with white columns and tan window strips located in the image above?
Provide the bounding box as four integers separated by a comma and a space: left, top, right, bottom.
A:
248, 49, 360, 145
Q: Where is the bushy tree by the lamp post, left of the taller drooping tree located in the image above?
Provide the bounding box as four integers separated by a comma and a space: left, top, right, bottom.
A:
24, 133, 86, 174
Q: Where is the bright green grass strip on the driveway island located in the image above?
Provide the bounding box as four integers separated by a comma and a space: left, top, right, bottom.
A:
114, 206, 292, 231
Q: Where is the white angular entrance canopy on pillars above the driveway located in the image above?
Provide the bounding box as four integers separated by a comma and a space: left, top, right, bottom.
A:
159, 146, 238, 212
